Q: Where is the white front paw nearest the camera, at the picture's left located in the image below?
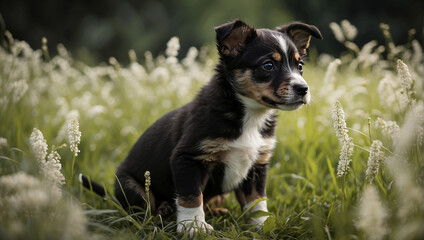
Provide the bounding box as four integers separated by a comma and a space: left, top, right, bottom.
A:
177, 202, 213, 238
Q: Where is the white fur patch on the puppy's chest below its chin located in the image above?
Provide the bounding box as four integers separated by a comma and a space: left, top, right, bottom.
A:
222, 94, 275, 192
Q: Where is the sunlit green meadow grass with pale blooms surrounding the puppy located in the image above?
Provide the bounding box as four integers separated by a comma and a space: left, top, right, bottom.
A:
0, 19, 424, 239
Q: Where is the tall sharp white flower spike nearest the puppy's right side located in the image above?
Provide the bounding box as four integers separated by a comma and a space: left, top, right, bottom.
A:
332, 101, 354, 177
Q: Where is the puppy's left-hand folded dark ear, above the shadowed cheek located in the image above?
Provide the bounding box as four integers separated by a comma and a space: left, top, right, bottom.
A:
215, 19, 256, 57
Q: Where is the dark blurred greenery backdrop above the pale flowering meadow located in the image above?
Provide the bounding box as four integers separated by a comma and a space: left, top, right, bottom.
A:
0, 0, 424, 65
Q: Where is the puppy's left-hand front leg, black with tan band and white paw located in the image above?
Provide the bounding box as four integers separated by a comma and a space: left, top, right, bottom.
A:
172, 157, 213, 237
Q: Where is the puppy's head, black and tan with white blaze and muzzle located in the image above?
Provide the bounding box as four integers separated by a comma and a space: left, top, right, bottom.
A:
215, 20, 322, 111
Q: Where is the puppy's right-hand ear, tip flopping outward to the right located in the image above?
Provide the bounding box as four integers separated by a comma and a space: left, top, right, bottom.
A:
277, 22, 323, 56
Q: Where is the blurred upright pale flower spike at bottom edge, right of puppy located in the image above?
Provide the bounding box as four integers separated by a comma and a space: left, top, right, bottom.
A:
356, 185, 388, 240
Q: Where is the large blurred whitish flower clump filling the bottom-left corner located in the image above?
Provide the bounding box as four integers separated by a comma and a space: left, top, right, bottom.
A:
0, 172, 91, 239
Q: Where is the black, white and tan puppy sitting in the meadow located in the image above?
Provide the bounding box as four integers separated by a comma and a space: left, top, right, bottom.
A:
83, 20, 322, 234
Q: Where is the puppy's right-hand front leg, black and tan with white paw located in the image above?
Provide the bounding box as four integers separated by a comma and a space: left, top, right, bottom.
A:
235, 164, 268, 228
